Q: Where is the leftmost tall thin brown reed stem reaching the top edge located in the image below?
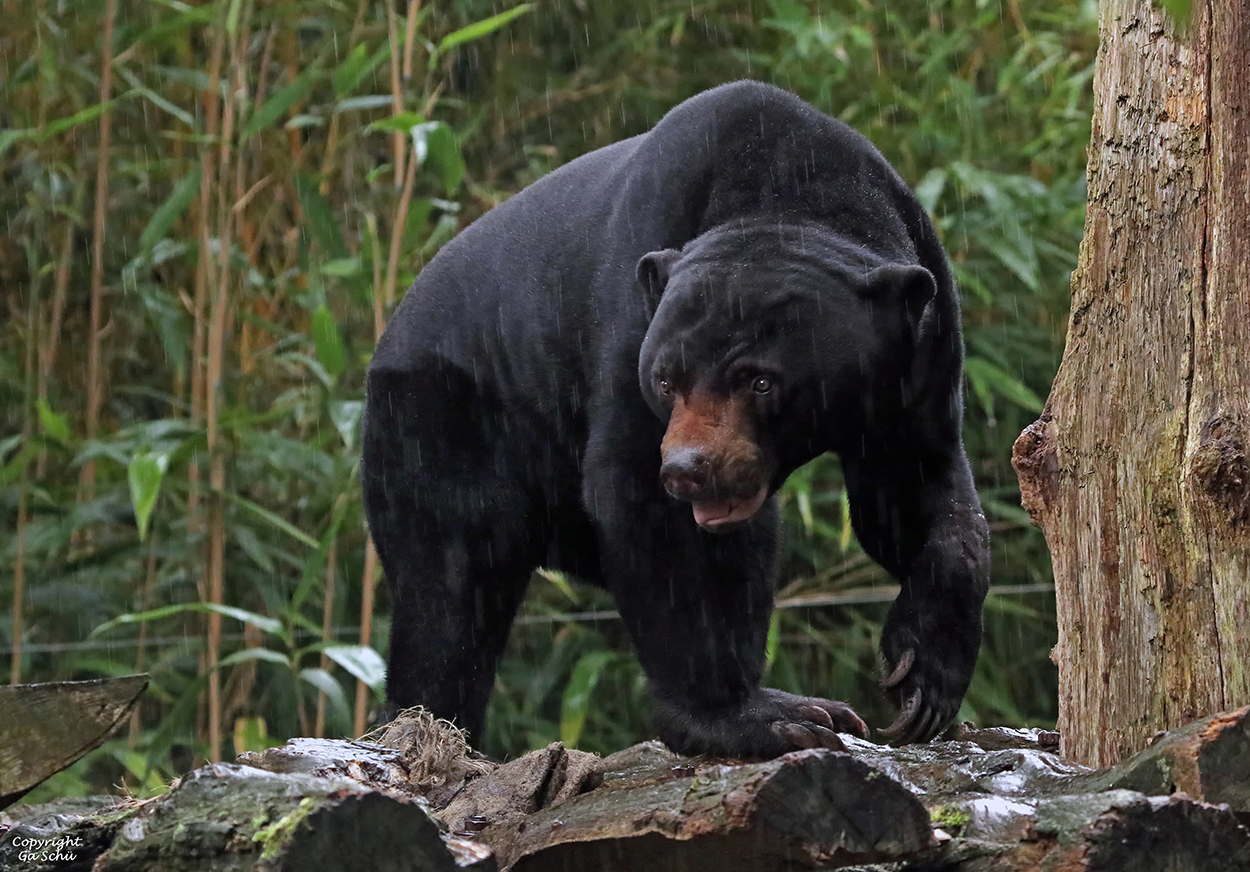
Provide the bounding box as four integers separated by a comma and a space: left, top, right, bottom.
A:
79, 0, 118, 509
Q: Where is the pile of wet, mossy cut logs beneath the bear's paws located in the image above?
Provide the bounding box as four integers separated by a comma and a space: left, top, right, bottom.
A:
0, 710, 1250, 872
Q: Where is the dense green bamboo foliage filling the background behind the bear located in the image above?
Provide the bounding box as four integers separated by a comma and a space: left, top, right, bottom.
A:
0, 0, 1096, 792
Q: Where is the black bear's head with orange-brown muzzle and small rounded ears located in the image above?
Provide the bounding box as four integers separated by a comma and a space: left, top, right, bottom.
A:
638, 221, 936, 530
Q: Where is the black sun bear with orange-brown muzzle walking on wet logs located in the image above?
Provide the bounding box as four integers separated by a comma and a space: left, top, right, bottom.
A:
361, 82, 989, 758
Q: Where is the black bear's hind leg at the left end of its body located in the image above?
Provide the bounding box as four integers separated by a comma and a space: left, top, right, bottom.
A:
360, 361, 541, 742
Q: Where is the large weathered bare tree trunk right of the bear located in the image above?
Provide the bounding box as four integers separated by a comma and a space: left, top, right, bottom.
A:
1013, 0, 1250, 766
